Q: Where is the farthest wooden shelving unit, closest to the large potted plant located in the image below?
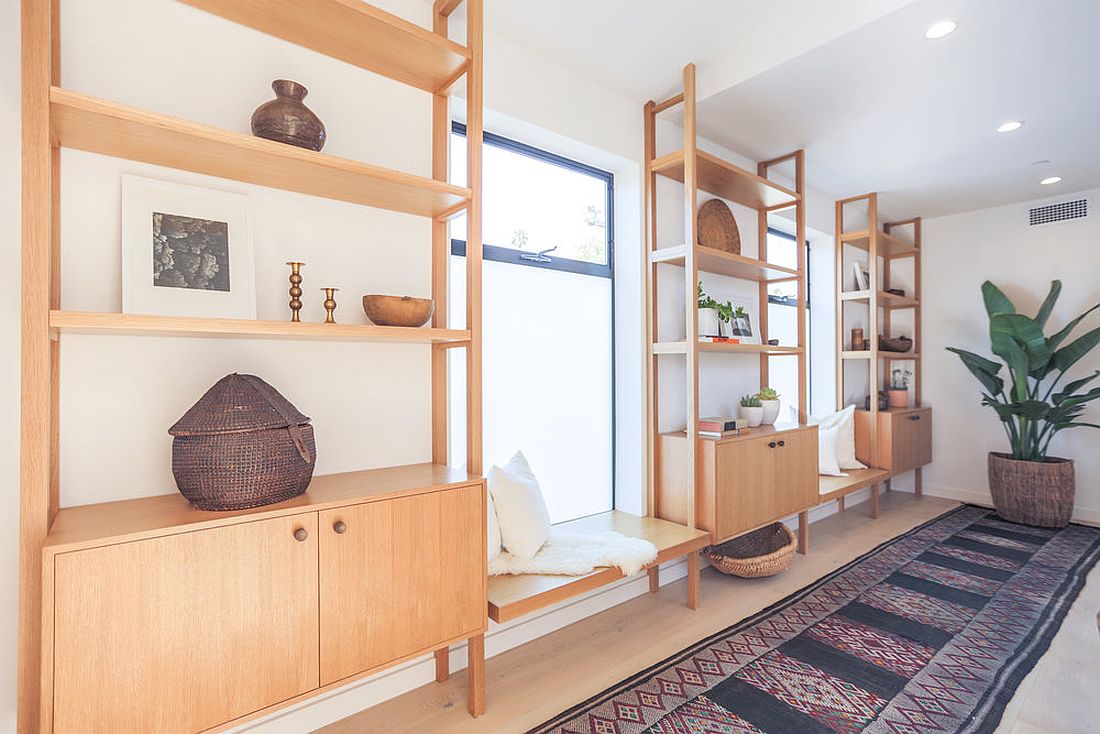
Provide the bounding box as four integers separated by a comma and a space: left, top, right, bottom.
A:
822, 193, 931, 508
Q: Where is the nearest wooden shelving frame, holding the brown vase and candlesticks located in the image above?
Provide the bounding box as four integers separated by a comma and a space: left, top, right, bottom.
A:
18, 0, 487, 732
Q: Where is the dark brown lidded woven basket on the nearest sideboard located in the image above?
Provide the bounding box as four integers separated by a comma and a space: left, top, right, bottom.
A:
168, 373, 317, 510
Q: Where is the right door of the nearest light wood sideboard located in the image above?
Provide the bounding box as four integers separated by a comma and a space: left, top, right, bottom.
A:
319, 484, 486, 686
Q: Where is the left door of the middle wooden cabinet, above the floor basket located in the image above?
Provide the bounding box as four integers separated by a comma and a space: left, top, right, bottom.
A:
714, 438, 776, 541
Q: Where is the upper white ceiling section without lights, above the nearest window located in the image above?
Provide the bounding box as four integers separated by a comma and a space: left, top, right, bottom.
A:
485, 0, 913, 105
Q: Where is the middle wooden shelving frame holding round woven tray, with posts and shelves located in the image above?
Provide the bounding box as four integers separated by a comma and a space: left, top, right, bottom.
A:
642, 64, 809, 581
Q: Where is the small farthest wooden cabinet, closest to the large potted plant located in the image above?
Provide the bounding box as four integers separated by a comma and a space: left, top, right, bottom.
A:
856, 408, 932, 474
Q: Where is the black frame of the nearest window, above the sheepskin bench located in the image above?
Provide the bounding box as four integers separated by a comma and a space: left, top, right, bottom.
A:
451, 120, 618, 519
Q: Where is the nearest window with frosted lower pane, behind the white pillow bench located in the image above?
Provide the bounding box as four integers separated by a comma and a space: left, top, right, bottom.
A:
449, 124, 615, 523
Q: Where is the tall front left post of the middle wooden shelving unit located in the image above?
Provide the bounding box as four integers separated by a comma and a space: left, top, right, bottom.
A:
683, 64, 700, 528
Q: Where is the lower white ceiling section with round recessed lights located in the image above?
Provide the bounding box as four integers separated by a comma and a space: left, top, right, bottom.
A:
700, 0, 1100, 217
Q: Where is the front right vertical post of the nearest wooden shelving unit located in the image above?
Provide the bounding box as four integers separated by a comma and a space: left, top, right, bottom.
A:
466, 0, 488, 716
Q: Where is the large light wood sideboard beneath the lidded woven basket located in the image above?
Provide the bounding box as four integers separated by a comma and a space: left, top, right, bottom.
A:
42, 464, 487, 734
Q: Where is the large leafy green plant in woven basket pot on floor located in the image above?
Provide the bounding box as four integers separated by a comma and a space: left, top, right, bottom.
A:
948, 281, 1100, 527
